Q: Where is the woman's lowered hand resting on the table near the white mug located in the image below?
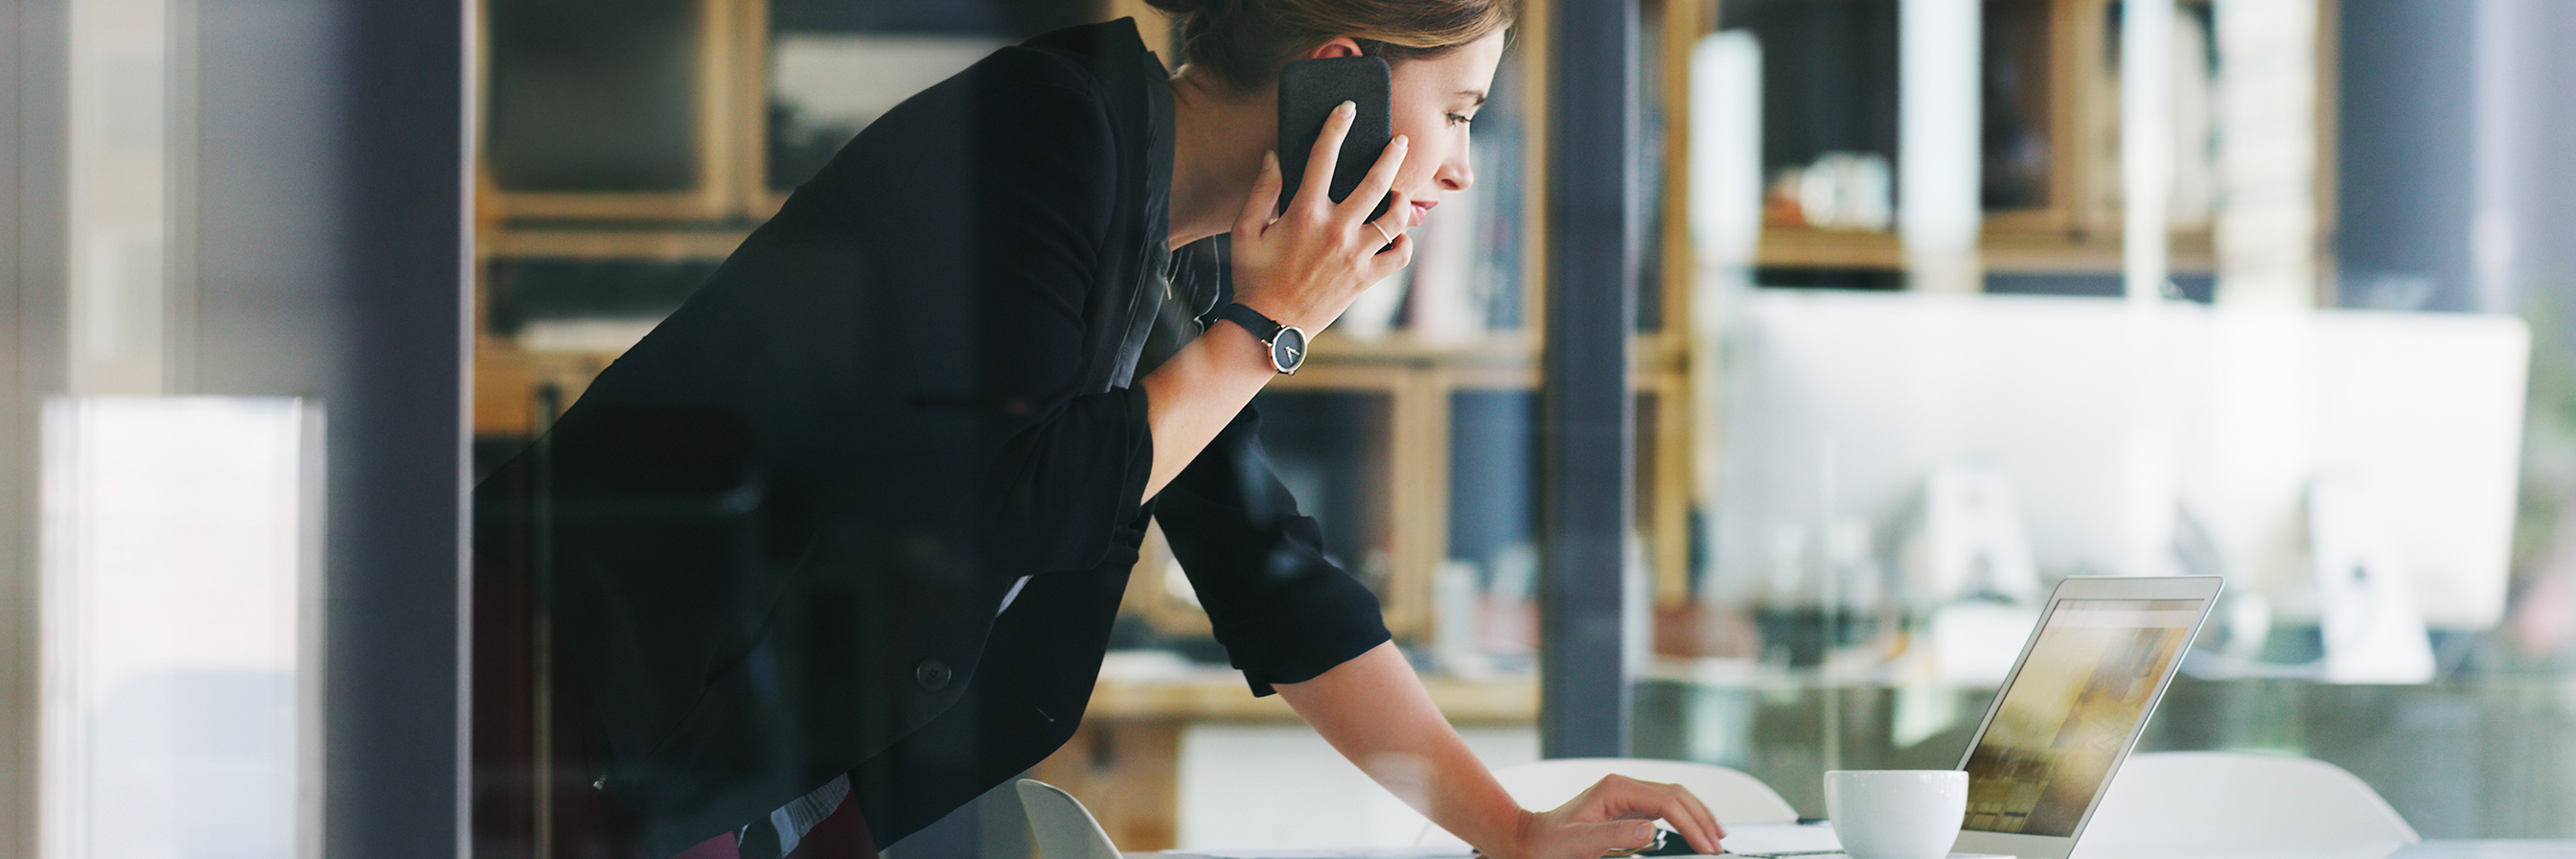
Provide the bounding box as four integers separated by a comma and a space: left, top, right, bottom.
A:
1489, 774, 1726, 859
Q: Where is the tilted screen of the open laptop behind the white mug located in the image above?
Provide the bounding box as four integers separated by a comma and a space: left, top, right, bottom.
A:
1966, 598, 2208, 838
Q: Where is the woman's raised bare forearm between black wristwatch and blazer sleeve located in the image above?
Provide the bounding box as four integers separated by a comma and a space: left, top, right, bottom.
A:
1141, 322, 1277, 498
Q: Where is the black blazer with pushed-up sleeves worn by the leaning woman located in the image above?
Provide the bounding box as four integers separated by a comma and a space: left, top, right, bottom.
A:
476, 21, 1389, 854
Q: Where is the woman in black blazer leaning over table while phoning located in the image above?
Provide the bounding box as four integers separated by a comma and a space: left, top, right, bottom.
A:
479, 0, 1721, 859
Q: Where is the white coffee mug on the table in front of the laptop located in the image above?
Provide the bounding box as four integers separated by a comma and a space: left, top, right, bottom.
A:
1824, 769, 1968, 859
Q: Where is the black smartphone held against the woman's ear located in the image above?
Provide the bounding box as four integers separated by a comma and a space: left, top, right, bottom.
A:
1280, 57, 1396, 220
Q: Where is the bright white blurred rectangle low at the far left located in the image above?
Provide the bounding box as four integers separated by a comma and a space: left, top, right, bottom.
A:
36, 397, 322, 859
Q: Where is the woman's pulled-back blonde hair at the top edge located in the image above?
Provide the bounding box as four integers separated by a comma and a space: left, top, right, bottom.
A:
1146, 0, 1520, 90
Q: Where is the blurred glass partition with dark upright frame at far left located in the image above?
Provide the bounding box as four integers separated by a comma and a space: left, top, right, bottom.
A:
0, 0, 469, 859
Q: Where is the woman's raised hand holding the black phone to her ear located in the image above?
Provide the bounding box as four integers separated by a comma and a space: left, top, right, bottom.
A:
1234, 101, 1414, 336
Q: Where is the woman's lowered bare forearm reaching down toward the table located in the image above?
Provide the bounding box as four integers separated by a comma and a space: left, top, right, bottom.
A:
1277, 642, 1530, 856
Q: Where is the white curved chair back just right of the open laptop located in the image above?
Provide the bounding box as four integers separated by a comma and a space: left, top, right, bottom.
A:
2077, 751, 2424, 859
